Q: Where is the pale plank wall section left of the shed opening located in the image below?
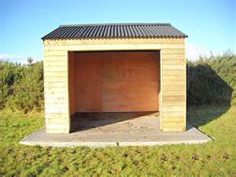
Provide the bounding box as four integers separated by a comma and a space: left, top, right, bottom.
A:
43, 41, 70, 133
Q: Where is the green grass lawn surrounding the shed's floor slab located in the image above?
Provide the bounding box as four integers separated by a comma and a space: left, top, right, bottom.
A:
0, 106, 236, 177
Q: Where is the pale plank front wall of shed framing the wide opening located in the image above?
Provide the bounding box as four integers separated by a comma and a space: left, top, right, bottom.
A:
44, 38, 186, 133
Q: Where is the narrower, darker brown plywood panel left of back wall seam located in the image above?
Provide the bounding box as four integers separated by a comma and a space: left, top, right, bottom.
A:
74, 54, 102, 112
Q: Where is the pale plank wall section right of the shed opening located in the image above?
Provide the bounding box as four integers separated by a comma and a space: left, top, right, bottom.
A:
161, 48, 186, 131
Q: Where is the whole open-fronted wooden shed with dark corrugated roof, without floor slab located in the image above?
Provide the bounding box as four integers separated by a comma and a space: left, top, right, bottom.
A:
42, 23, 187, 133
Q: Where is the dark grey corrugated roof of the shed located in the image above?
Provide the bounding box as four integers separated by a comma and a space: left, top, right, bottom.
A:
42, 23, 188, 40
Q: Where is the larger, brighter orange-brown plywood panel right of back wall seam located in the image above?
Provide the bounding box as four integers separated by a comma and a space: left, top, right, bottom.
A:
102, 52, 159, 112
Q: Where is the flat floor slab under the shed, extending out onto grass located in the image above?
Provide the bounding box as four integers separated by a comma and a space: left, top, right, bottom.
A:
20, 112, 211, 147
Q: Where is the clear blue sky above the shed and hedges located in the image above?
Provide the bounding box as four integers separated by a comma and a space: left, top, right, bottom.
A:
0, 0, 236, 61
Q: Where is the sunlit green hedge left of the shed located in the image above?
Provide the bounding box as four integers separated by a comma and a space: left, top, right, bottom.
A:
0, 61, 43, 112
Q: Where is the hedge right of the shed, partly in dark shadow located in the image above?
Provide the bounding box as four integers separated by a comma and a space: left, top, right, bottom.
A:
187, 52, 236, 105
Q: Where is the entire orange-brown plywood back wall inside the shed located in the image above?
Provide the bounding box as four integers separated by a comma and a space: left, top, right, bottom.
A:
69, 51, 160, 114
